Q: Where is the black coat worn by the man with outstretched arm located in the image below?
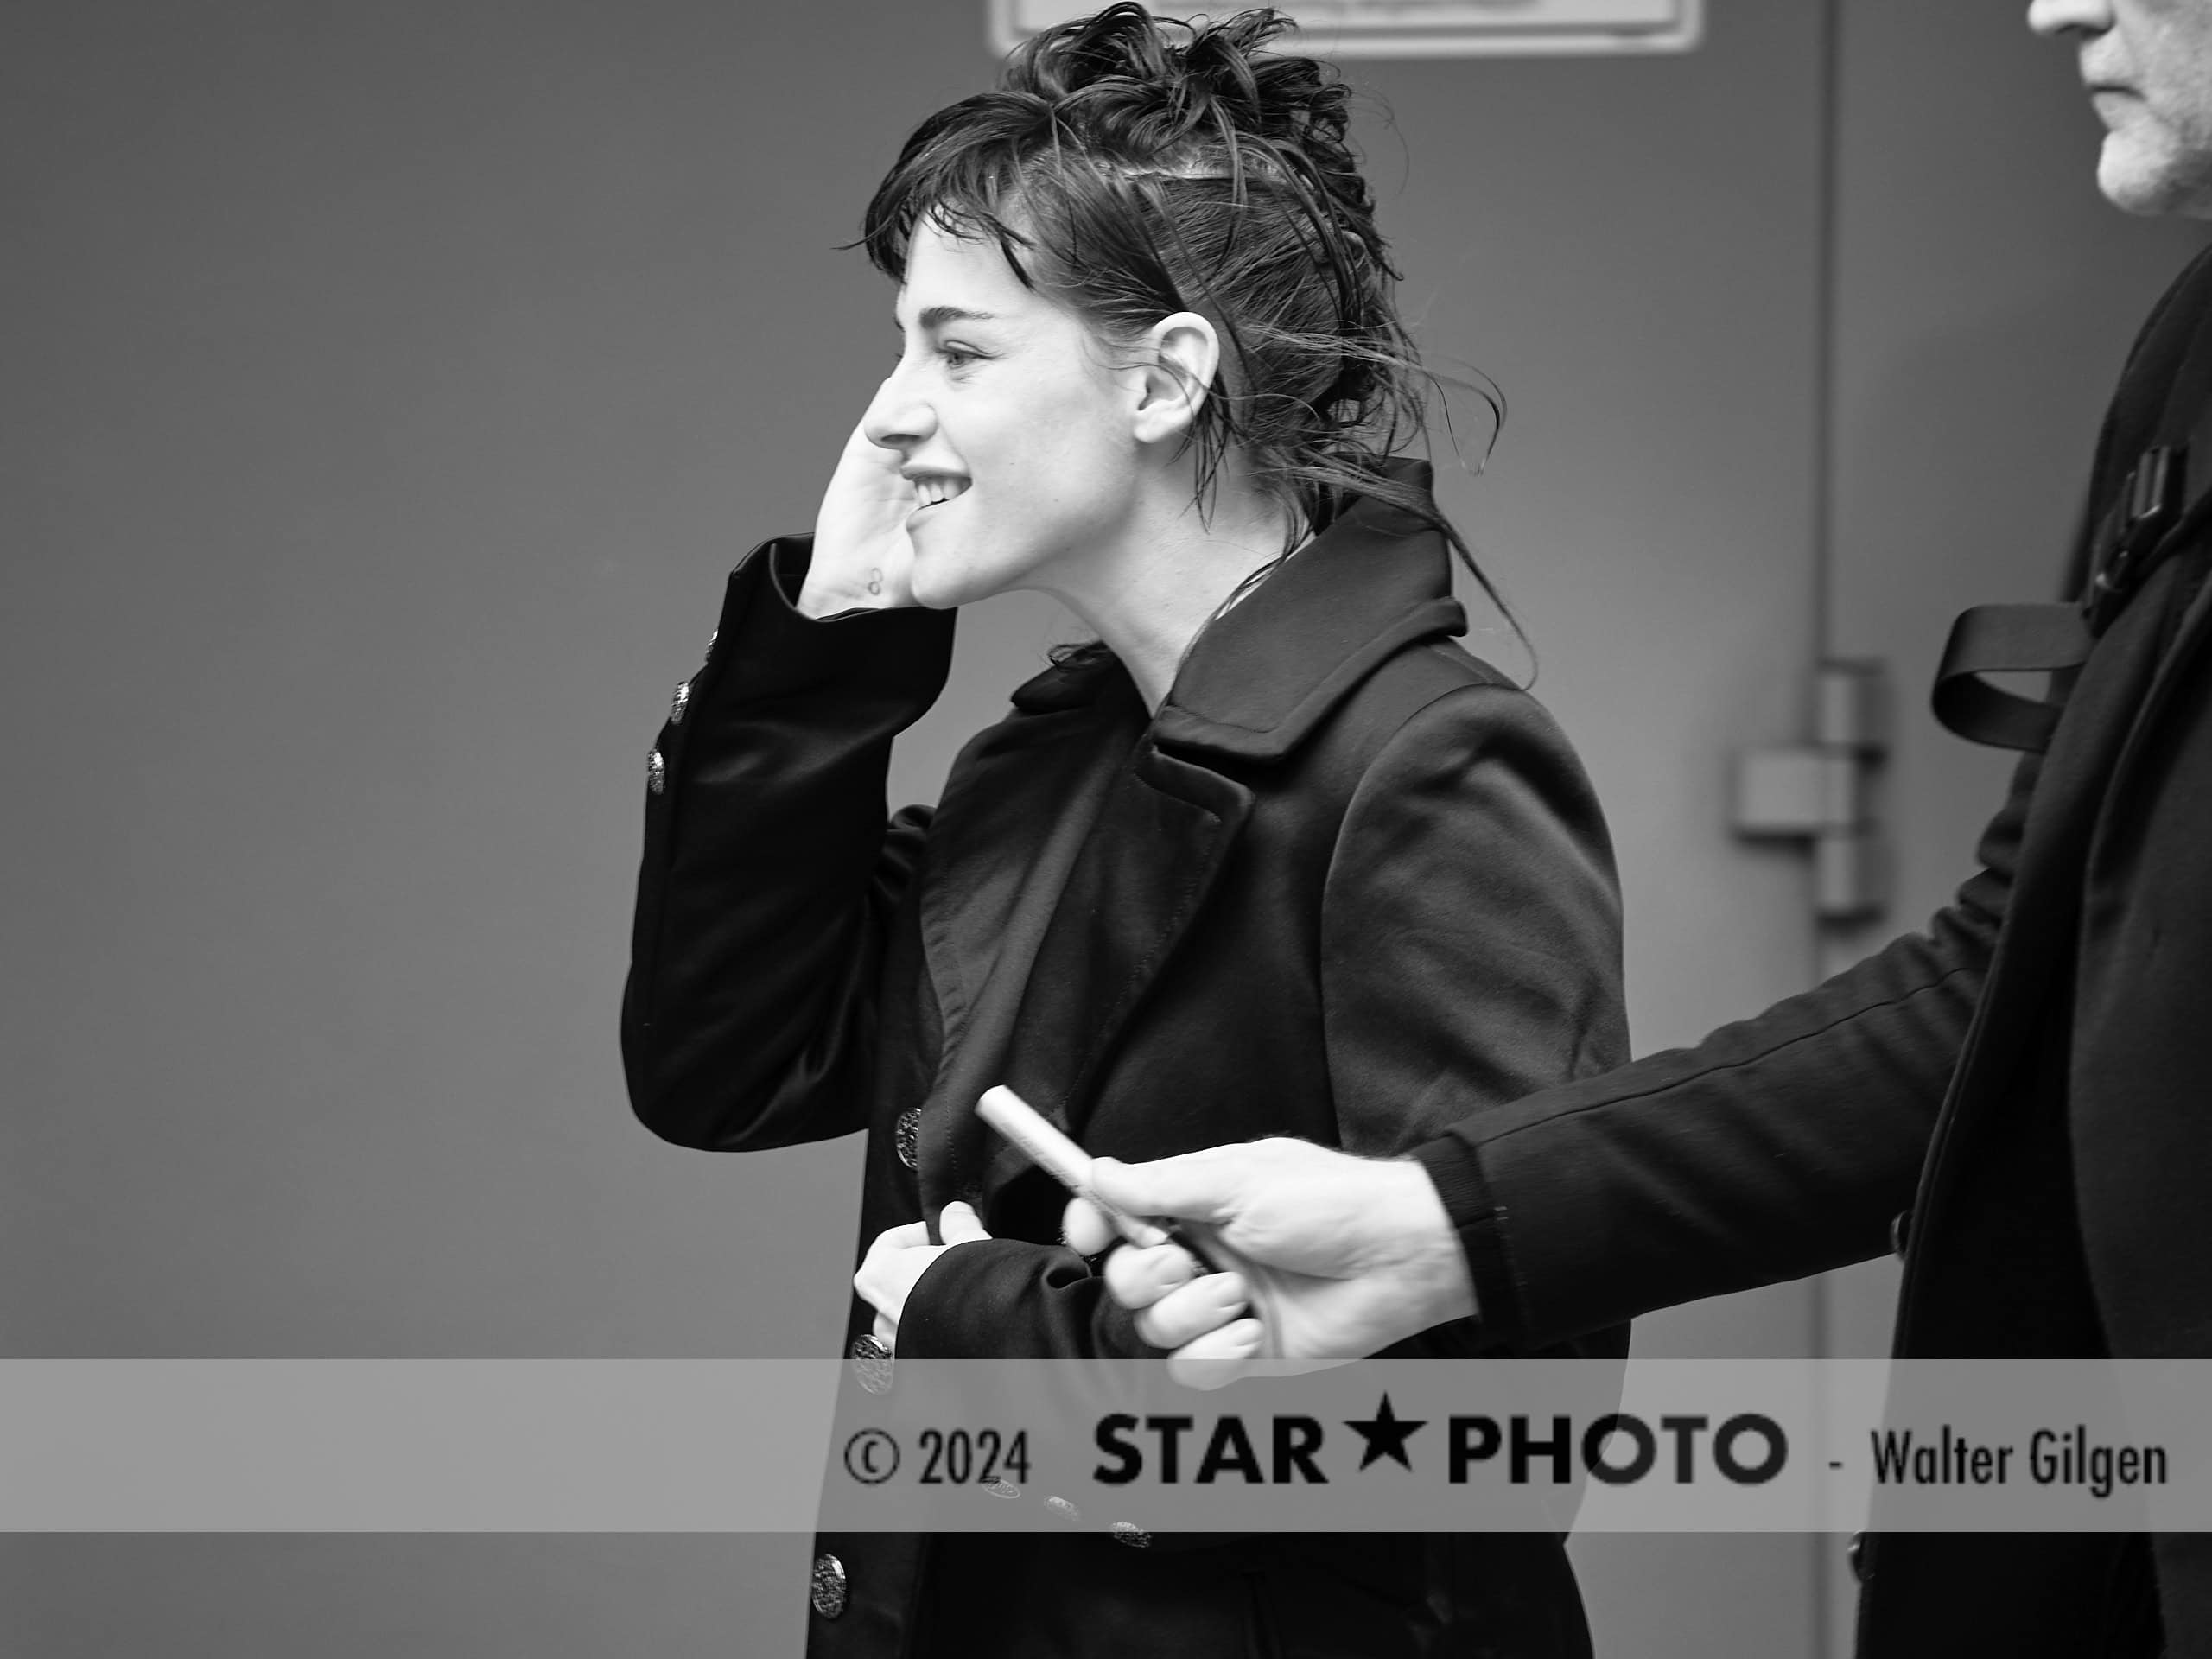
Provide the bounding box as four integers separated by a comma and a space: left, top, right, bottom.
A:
1421, 239, 2212, 1659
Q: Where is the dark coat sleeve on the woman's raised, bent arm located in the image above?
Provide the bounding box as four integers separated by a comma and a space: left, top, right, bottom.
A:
621, 536, 953, 1153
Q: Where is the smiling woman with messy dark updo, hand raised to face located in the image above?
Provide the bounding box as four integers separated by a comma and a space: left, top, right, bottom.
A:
624, 4, 1626, 1659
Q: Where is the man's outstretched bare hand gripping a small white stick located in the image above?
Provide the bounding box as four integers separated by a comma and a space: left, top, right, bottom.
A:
1068, 1139, 1476, 1387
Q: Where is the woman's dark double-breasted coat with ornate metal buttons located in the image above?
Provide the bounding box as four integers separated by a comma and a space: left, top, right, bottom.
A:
624, 473, 1626, 1659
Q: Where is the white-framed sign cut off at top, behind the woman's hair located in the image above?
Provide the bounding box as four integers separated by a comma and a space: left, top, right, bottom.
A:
991, 0, 1706, 58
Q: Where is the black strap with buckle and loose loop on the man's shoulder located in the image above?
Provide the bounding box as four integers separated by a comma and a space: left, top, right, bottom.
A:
1929, 261, 2212, 752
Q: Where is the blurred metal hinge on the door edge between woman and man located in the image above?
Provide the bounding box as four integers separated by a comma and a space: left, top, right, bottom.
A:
1730, 659, 1891, 923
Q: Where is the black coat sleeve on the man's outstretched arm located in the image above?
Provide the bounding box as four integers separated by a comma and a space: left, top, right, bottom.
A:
1415, 757, 2039, 1344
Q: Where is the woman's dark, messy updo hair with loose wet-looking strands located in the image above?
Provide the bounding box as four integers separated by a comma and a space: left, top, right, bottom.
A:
861, 3, 1497, 619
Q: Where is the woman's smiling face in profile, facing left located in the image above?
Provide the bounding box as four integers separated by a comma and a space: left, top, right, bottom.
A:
862, 217, 1141, 608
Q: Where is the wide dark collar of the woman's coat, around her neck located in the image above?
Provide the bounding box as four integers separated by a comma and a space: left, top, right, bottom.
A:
1013, 460, 1466, 761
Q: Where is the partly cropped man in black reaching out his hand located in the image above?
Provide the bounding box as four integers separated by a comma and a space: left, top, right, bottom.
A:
1071, 0, 2212, 1659
